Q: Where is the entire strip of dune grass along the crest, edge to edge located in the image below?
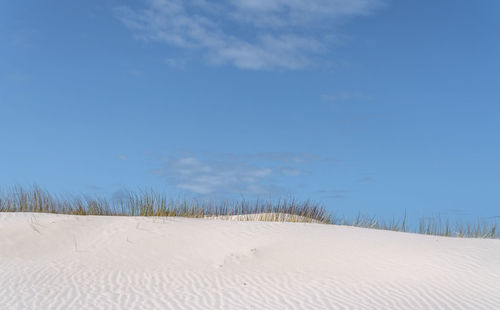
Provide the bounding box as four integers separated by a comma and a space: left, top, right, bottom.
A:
0, 186, 500, 238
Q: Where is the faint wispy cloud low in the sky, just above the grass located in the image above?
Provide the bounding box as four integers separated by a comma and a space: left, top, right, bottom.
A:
151, 153, 336, 197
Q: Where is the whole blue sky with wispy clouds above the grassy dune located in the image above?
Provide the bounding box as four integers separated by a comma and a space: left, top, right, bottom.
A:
0, 0, 500, 218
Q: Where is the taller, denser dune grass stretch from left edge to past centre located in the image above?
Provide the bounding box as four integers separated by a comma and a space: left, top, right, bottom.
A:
0, 186, 331, 224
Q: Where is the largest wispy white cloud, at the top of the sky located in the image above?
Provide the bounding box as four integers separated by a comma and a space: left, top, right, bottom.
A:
115, 0, 382, 70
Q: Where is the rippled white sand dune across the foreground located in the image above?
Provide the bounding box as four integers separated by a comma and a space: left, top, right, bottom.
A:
0, 213, 500, 310
